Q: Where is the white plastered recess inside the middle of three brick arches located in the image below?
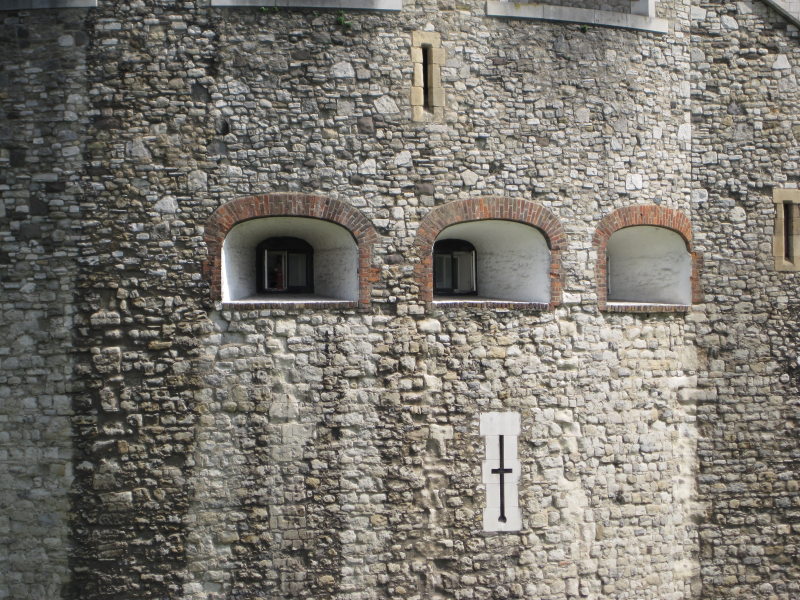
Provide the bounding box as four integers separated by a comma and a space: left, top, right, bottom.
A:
433, 219, 550, 304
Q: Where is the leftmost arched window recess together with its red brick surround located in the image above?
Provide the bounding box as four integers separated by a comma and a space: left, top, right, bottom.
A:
203, 193, 378, 308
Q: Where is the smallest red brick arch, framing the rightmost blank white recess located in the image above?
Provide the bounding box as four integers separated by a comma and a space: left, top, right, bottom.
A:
592, 204, 702, 312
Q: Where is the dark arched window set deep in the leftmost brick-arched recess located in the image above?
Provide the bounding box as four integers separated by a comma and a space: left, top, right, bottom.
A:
256, 237, 314, 294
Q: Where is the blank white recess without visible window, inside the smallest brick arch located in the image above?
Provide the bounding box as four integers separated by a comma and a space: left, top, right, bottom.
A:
606, 225, 692, 305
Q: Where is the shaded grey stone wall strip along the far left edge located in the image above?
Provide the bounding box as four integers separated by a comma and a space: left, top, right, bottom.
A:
0, 10, 88, 598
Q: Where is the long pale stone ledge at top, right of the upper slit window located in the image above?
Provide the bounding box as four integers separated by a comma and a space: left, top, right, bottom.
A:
486, 0, 669, 33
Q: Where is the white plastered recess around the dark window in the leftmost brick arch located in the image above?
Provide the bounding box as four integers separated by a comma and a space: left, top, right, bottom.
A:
222, 217, 358, 302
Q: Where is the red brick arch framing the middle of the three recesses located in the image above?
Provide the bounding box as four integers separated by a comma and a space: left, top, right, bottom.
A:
414, 196, 566, 307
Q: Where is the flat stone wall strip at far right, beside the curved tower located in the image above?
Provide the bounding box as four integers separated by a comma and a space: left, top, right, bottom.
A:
692, 2, 800, 599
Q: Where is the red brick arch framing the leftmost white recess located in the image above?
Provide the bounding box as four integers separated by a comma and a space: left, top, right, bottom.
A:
203, 194, 379, 306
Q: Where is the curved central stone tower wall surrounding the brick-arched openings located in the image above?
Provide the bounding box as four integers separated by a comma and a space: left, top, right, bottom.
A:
65, 3, 698, 599
